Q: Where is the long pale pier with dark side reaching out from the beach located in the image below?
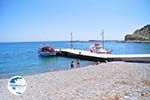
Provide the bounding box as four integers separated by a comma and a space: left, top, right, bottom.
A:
56, 49, 150, 62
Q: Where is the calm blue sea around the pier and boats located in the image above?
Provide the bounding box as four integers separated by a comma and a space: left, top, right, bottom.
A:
0, 41, 150, 78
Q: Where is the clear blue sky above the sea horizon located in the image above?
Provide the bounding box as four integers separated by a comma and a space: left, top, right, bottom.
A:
0, 0, 150, 42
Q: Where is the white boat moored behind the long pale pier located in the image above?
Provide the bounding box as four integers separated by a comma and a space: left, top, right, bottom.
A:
90, 43, 111, 54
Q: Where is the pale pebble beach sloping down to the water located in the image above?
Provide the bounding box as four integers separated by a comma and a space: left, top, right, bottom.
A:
0, 62, 150, 100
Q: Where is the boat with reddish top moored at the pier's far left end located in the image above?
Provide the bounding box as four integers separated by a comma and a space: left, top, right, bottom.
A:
38, 46, 57, 57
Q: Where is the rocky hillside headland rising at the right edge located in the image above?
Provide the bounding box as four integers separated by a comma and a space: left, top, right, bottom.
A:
125, 25, 150, 41
